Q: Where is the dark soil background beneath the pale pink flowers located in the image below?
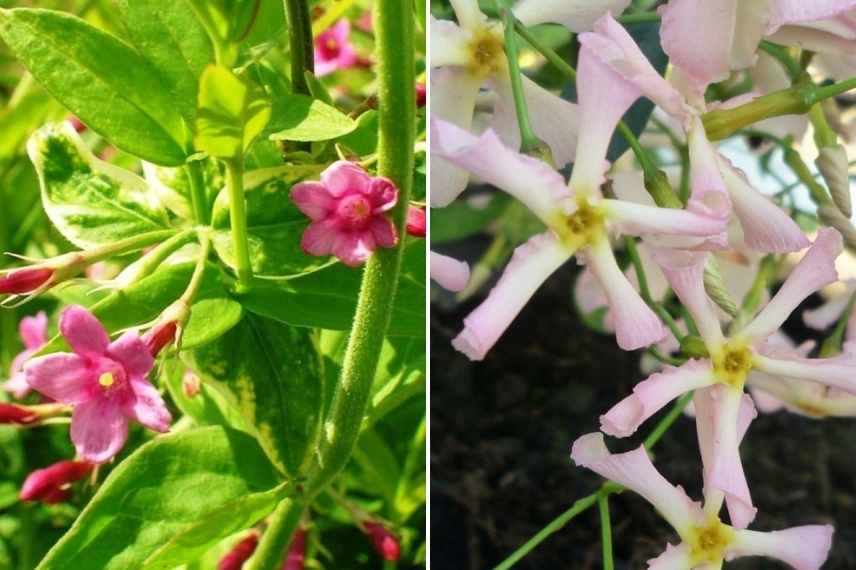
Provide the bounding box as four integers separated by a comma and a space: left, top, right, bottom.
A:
431, 252, 856, 570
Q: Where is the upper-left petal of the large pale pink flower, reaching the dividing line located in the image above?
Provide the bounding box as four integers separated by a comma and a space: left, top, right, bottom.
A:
431, 119, 571, 226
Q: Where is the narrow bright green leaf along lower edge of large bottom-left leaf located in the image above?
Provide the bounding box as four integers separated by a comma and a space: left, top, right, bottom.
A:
142, 487, 287, 570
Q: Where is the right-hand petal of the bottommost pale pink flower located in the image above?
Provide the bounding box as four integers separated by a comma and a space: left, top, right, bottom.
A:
727, 524, 835, 570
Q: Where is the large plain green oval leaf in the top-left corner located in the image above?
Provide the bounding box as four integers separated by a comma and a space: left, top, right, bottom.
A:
0, 8, 189, 165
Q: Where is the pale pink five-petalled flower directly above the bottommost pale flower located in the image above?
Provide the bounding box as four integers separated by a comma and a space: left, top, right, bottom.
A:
600, 229, 856, 528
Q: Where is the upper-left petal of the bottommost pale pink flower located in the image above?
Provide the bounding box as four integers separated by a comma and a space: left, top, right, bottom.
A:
571, 433, 704, 532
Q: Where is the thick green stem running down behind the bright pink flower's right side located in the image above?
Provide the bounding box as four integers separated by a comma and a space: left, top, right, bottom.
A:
308, 0, 416, 496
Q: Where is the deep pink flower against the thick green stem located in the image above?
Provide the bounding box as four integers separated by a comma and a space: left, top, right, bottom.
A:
291, 160, 398, 267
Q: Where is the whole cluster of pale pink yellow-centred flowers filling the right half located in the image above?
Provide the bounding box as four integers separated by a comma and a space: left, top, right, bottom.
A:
431, 0, 856, 570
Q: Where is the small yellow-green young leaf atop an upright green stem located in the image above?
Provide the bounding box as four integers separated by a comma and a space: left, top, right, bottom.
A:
194, 65, 271, 158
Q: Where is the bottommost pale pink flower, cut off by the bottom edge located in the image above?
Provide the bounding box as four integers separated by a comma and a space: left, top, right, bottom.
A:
571, 433, 834, 570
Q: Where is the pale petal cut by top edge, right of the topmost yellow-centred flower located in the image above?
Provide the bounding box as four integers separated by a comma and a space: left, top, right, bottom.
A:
514, 0, 631, 34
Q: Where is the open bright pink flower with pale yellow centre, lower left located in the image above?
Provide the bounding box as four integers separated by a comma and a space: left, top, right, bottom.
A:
24, 306, 172, 463
